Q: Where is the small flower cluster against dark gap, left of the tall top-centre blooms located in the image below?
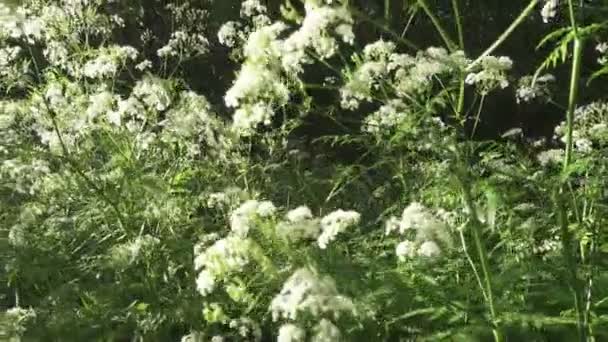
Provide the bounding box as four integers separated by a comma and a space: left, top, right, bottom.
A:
156, 31, 209, 60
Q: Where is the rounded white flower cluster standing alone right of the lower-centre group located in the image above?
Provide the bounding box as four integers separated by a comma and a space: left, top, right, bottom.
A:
386, 202, 452, 261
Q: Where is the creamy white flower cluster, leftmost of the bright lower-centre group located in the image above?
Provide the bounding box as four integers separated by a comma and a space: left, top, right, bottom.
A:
194, 236, 252, 296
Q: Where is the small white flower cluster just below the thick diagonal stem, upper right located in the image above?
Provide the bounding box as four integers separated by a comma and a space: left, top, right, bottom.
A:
465, 56, 513, 95
